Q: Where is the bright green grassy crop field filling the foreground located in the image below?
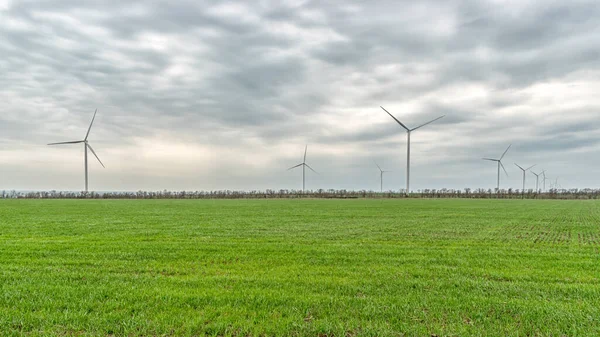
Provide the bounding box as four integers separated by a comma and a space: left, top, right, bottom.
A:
0, 200, 600, 336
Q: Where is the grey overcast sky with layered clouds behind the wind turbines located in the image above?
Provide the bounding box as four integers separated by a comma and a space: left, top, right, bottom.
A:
0, 0, 600, 191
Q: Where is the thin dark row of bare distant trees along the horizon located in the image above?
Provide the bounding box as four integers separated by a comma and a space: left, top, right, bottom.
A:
0, 188, 600, 199
